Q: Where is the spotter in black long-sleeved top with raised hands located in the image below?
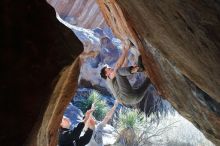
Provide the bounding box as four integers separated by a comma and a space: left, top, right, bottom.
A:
58, 109, 96, 146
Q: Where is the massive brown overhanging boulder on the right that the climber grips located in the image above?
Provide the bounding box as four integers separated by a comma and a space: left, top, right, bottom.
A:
98, 0, 220, 145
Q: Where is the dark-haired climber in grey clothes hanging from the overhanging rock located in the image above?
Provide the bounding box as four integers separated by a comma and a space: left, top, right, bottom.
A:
100, 40, 150, 105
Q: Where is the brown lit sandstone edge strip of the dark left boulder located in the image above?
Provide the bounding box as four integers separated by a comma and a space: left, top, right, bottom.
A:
34, 59, 80, 146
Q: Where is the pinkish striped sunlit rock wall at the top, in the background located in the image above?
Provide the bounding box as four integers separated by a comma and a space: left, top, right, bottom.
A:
47, 0, 107, 29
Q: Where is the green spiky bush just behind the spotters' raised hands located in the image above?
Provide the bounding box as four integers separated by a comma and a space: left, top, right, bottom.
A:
79, 91, 109, 121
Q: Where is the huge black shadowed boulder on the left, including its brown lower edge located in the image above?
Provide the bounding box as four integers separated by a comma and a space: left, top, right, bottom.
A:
0, 0, 83, 146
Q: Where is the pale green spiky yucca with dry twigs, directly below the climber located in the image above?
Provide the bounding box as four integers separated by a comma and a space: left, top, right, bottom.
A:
116, 108, 172, 146
